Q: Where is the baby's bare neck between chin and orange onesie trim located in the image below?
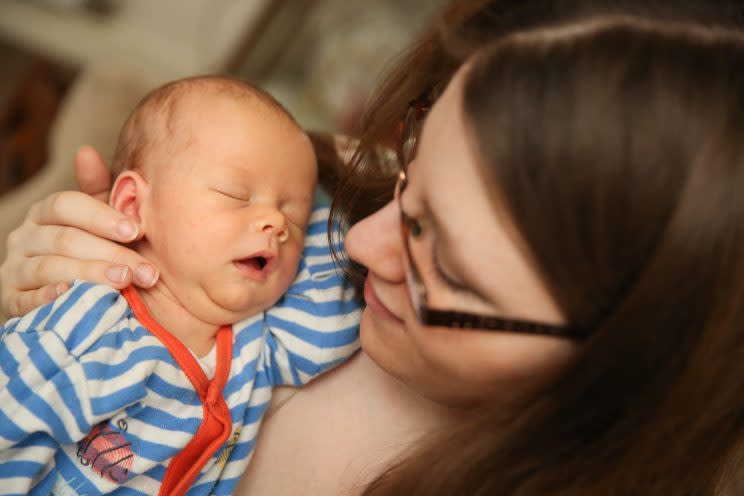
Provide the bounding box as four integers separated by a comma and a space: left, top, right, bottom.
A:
137, 280, 220, 357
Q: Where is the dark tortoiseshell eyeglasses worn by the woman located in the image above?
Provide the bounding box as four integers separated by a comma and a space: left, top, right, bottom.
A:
395, 100, 586, 340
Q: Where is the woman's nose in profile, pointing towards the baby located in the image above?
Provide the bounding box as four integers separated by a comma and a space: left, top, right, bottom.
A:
344, 202, 406, 282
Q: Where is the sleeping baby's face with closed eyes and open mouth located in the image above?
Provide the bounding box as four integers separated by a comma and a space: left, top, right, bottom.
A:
140, 96, 317, 324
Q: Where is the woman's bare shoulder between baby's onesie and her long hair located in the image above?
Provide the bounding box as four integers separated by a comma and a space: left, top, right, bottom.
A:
235, 352, 454, 495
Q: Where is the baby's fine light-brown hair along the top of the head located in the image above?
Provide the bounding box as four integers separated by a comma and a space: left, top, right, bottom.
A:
111, 75, 299, 176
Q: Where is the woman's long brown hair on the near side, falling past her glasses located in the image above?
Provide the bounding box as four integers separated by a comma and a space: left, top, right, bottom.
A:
365, 18, 744, 496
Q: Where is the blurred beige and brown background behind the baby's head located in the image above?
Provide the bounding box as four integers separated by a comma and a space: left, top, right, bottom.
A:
0, 0, 445, 270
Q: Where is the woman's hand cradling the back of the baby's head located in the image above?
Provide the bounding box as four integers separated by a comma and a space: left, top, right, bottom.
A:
0, 147, 158, 316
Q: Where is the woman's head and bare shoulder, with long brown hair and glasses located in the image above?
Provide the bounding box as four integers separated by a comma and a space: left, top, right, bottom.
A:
1, 6, 744, 494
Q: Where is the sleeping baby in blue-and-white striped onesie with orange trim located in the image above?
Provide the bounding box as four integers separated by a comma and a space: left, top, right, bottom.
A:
0, 76, 359, 495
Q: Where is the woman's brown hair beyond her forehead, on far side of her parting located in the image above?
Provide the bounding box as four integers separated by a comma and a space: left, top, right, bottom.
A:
328, 0, 744, 283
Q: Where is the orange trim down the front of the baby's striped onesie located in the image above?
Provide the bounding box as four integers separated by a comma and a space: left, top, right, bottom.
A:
121, 286, 233, 496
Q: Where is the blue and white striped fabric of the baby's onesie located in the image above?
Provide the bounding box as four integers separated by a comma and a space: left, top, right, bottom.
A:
0, 203, 360, 496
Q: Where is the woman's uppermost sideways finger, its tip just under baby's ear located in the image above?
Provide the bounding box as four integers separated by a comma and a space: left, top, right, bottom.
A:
28, 191, 142, 243
